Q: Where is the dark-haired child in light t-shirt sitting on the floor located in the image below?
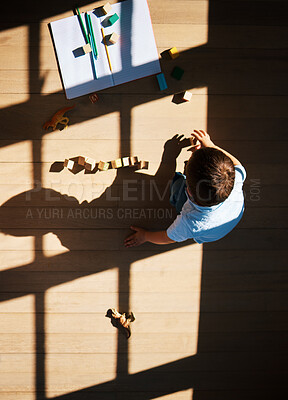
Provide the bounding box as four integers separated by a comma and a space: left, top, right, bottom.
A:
124, 130, 246, 247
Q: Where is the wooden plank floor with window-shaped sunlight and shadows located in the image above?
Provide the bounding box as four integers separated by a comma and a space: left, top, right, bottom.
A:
0, 0, 288, 400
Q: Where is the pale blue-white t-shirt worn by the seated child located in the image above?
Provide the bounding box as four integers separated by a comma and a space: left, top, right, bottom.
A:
167, 165, 246, 243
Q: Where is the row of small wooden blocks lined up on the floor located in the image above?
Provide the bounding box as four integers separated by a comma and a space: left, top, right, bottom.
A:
64, 156, 149, 171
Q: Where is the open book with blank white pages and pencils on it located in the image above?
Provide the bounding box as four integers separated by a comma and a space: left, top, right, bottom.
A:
49, 0, 161, 99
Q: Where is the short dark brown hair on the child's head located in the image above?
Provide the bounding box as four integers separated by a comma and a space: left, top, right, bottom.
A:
186, 147, 235, 206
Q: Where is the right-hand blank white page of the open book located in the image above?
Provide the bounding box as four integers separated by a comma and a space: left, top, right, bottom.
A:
101, 0, 161, 85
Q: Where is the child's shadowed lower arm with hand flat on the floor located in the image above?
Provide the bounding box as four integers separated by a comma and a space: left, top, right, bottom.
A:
124, 226, 174, 247
